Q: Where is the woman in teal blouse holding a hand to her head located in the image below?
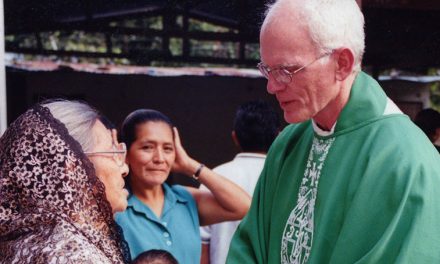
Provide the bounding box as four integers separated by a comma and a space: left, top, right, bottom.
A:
116, 109, 250, 264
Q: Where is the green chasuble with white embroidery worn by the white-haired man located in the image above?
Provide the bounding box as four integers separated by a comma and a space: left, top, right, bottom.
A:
227, 72, 440, 264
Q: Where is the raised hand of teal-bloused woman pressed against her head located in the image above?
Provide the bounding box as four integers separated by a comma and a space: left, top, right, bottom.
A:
172, 127, 200, 176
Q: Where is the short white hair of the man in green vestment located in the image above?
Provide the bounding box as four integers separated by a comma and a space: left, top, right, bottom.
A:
266, 0, 365, 71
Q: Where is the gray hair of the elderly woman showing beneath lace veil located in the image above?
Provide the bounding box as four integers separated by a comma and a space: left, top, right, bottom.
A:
42, 100, 100, 152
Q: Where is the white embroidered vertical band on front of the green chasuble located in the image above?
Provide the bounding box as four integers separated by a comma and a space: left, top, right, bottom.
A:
281, 137, 334, 264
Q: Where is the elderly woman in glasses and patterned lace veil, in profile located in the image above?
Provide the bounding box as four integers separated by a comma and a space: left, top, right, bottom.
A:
0, 101, 130, 263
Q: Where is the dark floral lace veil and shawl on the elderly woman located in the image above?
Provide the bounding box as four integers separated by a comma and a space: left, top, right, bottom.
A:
0, 106, 130, 263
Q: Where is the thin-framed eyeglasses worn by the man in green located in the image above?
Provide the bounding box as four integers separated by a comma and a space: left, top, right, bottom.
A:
257, 52, 332, 84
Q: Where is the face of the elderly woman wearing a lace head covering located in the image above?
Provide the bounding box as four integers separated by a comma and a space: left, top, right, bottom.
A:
88, 121, 128, 213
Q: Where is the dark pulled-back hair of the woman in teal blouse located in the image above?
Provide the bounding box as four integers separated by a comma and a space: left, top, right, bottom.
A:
121, 109, 173, 149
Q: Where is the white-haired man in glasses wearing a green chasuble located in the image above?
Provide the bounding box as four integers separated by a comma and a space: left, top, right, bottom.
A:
227, 0, 440, 264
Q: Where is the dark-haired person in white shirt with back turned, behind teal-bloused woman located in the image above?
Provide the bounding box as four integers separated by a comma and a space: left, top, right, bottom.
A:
201, 101, 280, 264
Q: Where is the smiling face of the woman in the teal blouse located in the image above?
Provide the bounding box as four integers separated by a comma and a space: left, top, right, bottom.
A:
127, 121, 176, 188
